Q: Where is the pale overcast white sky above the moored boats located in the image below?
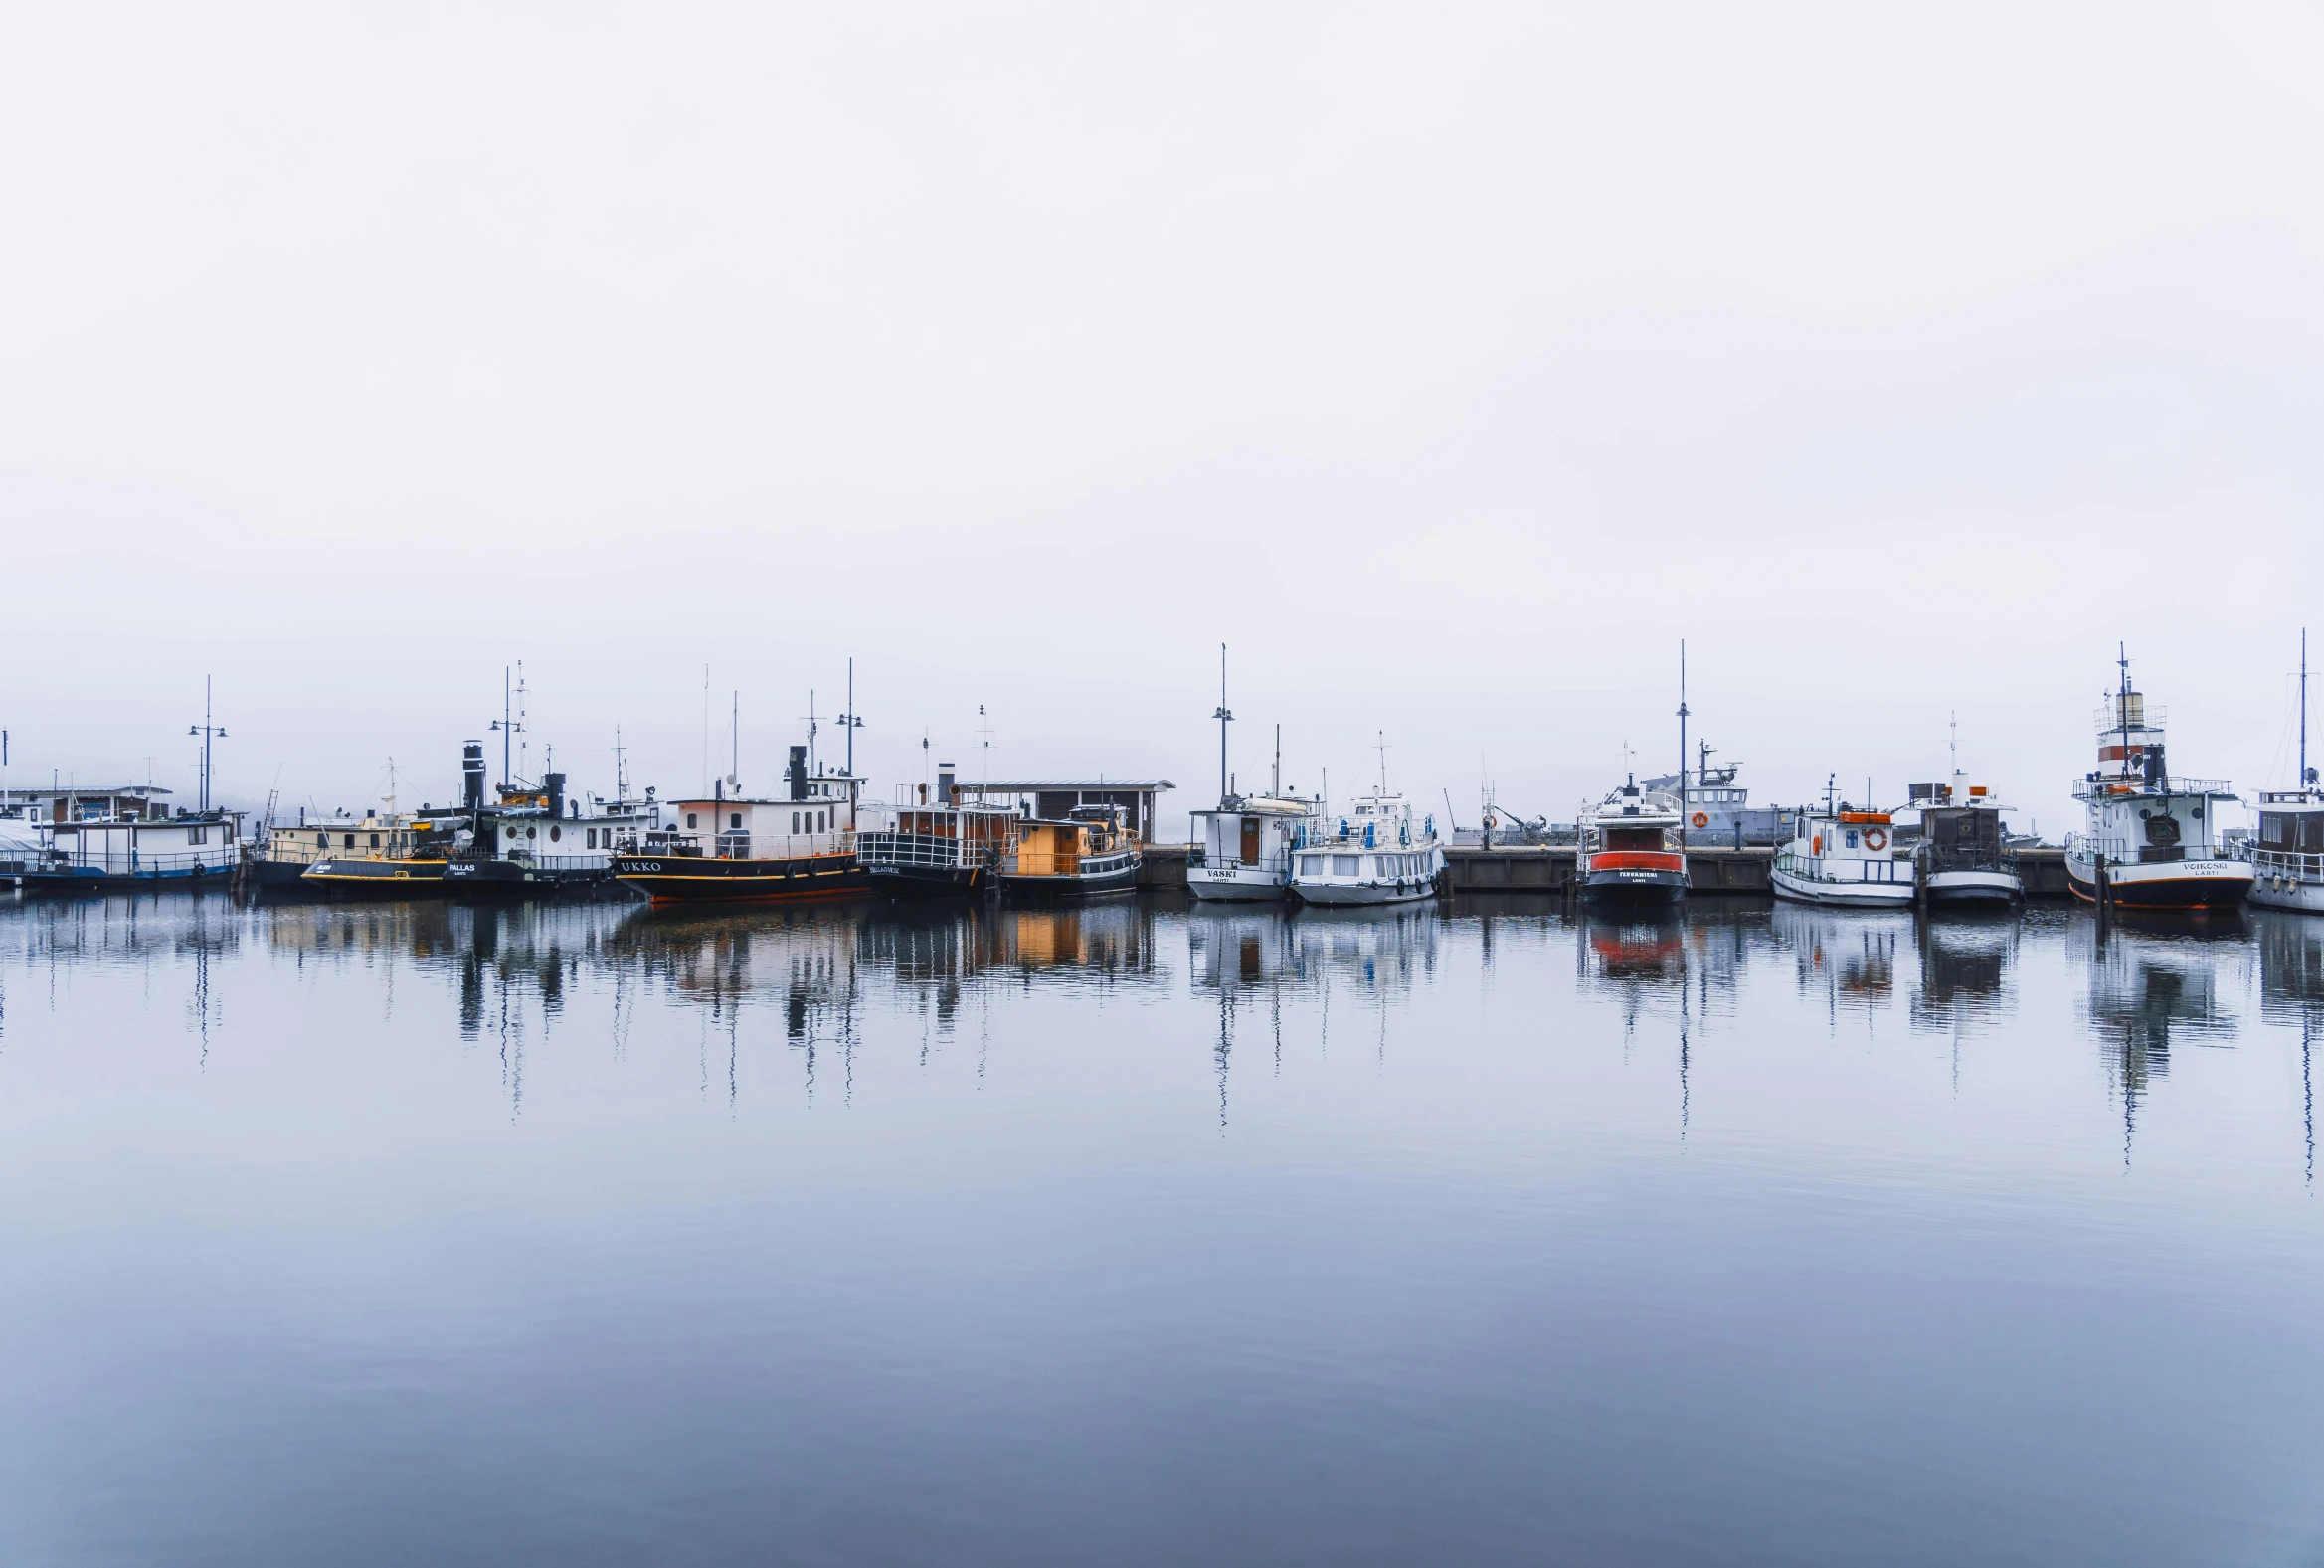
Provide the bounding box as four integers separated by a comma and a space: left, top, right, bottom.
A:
0, 2, 2324, 838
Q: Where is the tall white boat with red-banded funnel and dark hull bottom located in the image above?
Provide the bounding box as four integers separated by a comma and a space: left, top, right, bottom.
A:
2066, 655, 2254, 911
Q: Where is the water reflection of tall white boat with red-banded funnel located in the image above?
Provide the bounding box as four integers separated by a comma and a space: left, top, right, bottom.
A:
2066, 911, 2249, 1161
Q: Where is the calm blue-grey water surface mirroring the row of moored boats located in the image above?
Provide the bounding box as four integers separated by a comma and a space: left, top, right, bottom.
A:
0, 897, 2324, 1566
